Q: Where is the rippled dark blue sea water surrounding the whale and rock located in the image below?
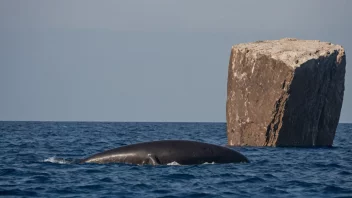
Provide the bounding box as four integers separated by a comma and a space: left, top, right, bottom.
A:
0, 122, 352, 197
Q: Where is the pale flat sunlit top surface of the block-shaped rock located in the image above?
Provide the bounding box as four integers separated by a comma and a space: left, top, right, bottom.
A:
232, 38, 344, 68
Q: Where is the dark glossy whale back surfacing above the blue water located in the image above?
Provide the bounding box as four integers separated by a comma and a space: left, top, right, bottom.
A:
80, 140, 249, 165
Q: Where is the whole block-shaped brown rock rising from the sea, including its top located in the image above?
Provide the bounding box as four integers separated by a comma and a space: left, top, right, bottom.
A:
226, 39, 346, 146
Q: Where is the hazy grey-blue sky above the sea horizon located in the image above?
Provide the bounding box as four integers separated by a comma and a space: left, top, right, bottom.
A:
0, 0, 352, 123
